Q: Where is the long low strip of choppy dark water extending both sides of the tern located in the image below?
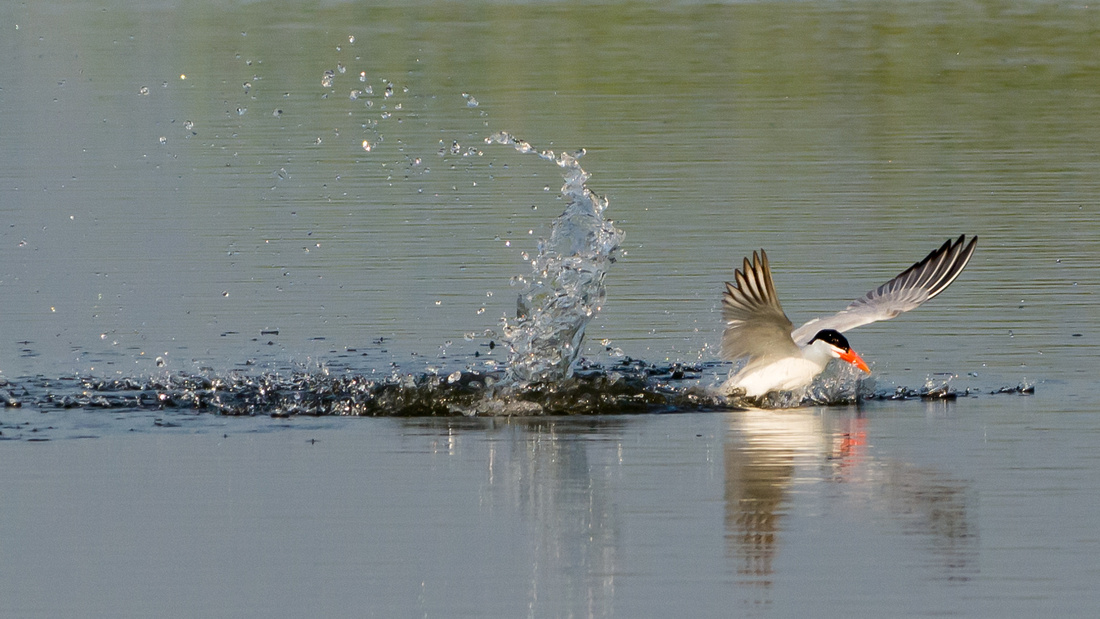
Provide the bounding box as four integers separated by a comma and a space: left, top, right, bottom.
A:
0, 360, 1035, 433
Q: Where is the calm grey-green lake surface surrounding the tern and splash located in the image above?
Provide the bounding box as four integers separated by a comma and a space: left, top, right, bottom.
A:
0, 1, 1100, 617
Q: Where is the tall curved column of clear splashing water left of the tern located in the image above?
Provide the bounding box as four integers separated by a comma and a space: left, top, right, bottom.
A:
485, 132, 624, 387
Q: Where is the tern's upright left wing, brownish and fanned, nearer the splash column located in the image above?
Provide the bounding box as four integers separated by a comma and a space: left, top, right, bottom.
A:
722, 250, 799, 362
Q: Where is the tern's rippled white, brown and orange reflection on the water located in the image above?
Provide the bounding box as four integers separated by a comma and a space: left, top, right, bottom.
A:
725, 409, 978, 604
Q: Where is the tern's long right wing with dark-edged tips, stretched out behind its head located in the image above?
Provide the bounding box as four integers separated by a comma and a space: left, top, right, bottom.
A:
792, 234, 978, 344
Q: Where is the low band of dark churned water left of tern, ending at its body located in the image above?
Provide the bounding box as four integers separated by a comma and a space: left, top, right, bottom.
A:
0, 361, 723, 424
